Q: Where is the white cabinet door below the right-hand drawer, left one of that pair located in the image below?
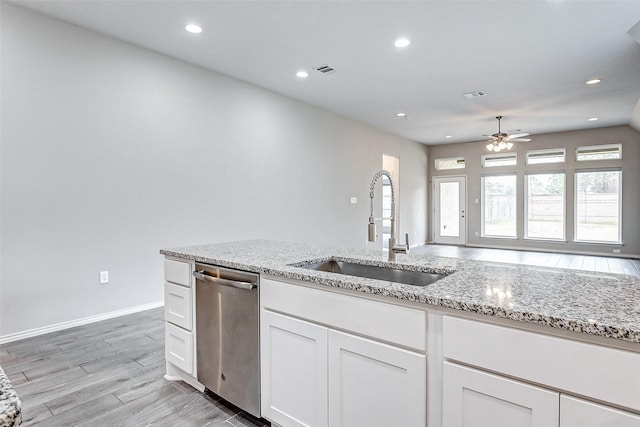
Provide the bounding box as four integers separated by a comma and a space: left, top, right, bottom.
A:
442, 362, 560, 427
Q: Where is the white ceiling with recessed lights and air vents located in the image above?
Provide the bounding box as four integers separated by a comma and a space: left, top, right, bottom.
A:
16, 0, 640, 144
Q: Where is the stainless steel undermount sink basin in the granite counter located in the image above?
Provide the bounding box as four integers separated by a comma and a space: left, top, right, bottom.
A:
298, 260, 446, 286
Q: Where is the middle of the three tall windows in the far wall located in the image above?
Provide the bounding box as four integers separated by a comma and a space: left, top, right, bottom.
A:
525, 173, 565, 240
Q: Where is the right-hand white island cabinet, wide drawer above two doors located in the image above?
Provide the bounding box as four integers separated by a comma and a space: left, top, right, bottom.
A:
442, 316, 640, 427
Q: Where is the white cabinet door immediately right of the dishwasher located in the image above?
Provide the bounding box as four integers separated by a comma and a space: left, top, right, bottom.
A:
260, 310, 327, 427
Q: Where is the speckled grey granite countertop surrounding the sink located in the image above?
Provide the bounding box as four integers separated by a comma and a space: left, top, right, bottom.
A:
160, 240, 640, 343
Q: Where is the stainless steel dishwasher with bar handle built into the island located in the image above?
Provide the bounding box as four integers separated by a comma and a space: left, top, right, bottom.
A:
193, 263, 260, 417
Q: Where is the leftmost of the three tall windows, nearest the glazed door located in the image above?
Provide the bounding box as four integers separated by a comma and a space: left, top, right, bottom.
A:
482, 175, 517, 237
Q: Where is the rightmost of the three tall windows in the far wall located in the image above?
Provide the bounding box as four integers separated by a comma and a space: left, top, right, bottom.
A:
575, 170, 622, 243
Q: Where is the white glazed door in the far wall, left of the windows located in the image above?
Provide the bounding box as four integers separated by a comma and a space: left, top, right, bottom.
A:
433, 176, 467, 245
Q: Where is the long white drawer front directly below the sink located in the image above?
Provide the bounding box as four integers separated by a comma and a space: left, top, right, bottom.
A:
260, 279, 427, 353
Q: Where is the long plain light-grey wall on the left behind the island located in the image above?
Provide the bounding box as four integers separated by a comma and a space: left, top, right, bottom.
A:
0, 2, 427, 336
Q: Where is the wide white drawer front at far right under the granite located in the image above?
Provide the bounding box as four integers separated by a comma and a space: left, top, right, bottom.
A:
442, 316, 640, 411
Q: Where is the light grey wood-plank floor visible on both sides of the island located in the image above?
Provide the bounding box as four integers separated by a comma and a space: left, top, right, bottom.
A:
0, 245, 640, 427
